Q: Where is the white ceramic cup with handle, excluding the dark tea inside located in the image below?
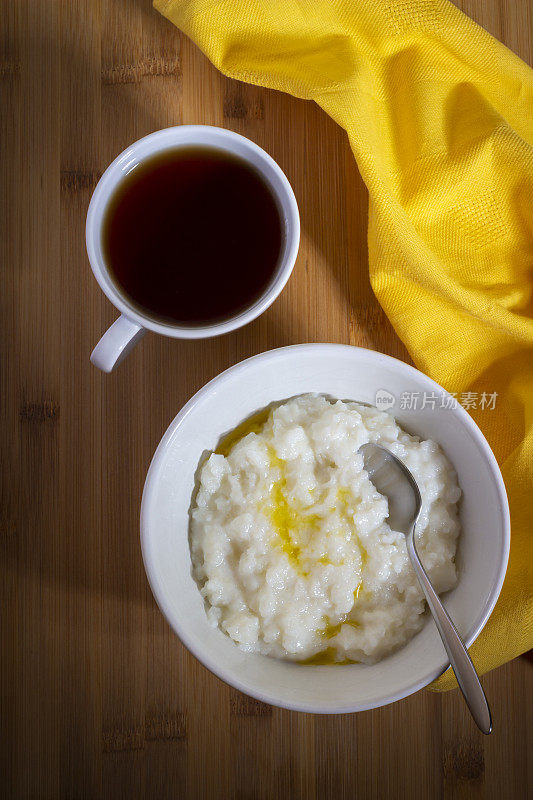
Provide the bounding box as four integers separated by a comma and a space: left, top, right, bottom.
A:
86, 125, 300, 372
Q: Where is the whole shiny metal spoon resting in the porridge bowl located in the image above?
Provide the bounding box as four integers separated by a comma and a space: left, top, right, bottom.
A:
359, 443, 492, 734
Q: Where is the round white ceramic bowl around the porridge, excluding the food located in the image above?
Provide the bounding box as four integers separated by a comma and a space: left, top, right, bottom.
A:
141, 344, 510, 714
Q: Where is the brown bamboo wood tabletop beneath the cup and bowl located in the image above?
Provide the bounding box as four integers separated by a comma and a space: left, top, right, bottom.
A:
4, 0, 533, 800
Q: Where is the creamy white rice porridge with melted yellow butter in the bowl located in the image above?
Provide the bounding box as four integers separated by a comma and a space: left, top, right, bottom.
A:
190, 395, 461, 664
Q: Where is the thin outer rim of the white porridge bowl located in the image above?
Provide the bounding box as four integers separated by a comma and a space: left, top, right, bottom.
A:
140, 342, 511, 714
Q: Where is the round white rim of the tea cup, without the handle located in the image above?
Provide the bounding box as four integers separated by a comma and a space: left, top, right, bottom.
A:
85, 125, 300, 339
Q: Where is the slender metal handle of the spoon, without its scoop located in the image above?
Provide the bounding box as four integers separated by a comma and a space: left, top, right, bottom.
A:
407, 525, 492, 734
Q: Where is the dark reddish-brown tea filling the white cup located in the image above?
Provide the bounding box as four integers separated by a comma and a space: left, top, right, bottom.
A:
103, 146, 285, 327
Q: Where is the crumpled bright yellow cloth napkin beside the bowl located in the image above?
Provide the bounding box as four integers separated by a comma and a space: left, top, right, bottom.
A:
154, 0, 533, 689
